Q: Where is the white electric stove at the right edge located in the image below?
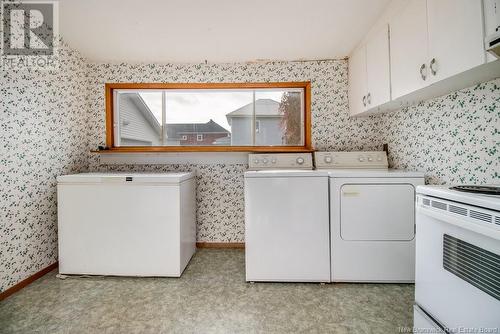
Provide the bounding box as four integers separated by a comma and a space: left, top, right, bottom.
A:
414, 186, 500, 333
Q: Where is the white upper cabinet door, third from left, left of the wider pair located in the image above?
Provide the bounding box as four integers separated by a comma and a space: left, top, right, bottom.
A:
389, 0, 428, 100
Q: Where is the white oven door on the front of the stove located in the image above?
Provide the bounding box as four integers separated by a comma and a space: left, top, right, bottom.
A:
415, 196, 500, 330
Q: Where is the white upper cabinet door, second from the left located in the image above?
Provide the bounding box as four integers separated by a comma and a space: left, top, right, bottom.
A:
366, 25, 391, 108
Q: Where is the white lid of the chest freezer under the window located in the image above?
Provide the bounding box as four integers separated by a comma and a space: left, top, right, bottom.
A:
57, 172, 195, 184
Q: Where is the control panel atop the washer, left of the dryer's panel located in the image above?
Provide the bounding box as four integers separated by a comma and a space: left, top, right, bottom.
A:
248, 153, 313, 170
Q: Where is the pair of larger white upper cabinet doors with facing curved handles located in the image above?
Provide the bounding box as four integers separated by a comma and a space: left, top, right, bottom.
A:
390, 0, 486, 101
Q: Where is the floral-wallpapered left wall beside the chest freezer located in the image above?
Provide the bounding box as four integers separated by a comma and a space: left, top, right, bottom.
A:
0, 48, 89, 291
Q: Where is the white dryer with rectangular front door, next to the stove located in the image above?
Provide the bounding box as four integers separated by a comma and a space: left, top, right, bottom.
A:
315, 152, 424, 282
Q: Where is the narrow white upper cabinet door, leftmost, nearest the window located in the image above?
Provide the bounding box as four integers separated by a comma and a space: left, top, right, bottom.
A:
349, 46, 366, 115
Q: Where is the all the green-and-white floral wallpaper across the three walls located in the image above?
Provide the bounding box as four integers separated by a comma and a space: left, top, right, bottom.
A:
0, 41, 500, 291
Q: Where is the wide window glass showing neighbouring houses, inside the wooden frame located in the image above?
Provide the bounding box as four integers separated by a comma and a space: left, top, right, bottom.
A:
114, 88, 304, 146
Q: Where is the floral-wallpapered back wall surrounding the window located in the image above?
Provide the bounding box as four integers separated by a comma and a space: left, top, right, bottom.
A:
89, 60, 380, 242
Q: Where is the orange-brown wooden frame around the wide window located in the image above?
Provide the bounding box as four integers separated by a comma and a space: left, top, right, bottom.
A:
104, 81, 313, 153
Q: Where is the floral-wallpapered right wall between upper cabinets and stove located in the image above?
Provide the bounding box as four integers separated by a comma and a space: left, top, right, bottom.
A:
380, 79, 500, 184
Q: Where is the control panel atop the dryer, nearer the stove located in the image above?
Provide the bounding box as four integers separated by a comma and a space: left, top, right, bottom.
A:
314, 151, 389, 169
